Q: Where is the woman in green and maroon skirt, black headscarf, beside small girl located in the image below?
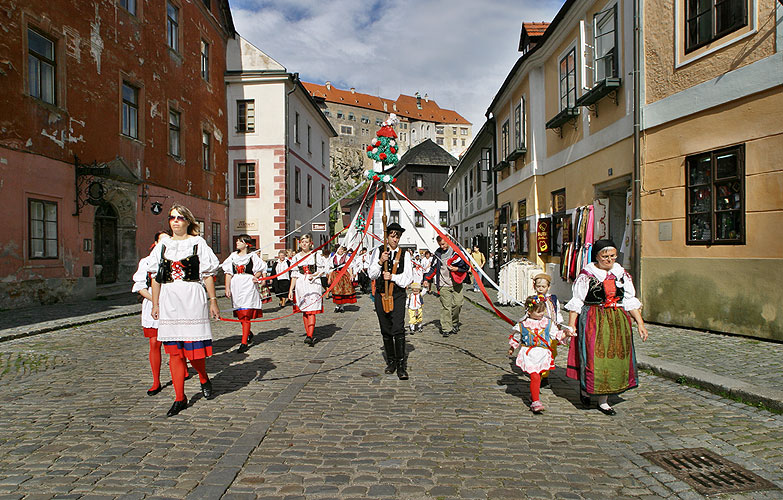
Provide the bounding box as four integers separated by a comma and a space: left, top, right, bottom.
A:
565, 240, 647, 415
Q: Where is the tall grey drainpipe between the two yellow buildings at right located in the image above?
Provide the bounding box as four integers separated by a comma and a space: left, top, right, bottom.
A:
632, 0, 642, 297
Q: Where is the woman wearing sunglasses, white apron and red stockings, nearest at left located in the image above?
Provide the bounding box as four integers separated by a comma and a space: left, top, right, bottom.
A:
150, 203, 220, 417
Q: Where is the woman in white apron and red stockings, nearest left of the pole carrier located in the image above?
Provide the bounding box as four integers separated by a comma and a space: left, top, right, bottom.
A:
288, 233, 329, 347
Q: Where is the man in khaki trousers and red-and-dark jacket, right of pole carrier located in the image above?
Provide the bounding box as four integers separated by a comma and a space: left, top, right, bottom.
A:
424, 236, 470, 337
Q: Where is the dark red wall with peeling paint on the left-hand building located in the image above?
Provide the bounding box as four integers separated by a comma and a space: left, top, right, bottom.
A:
0, 0, 234, 308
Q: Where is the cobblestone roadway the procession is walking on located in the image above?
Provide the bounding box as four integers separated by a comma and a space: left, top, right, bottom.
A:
0, 297, 783, 499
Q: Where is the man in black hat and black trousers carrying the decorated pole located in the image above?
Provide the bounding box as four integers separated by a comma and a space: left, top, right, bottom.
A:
367, 222, 413, 380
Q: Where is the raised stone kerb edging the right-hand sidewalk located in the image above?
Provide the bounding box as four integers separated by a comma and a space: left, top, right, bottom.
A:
465, 294, 783, 412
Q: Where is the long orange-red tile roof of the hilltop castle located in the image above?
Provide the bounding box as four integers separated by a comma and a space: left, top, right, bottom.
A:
302, 82, 470, 125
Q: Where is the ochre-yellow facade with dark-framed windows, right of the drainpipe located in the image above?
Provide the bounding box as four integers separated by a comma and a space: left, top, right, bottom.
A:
641, 0, 783, 340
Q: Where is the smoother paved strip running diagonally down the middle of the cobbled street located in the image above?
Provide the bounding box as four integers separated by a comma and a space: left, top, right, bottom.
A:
187, 316, 356, 500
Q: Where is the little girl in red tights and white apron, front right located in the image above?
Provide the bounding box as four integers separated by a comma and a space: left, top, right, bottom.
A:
508, 295, 573, 413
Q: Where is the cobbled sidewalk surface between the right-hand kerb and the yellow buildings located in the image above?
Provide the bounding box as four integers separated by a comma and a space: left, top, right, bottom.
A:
466, 291, 783, 396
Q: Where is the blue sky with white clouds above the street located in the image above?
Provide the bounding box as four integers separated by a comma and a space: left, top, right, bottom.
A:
230, 0, 563, 130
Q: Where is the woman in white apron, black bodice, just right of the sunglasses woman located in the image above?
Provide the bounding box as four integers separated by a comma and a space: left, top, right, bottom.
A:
221, 234, 266, 352
